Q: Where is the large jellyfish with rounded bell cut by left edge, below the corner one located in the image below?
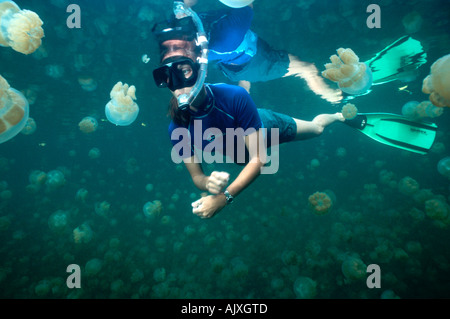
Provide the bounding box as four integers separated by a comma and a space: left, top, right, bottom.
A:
0, 74, 29, 144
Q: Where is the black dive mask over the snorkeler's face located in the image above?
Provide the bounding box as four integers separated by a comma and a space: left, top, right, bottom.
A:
153, 56, 200, 92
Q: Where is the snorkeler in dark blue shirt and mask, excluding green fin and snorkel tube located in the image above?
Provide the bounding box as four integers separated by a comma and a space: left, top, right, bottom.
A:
153, 3, 344, 218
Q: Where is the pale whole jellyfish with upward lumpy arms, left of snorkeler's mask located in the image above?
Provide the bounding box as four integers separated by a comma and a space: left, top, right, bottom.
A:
105, 82, 139, 126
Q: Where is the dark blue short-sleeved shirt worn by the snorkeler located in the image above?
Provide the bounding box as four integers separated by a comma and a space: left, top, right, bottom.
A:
169, 84, 262, 163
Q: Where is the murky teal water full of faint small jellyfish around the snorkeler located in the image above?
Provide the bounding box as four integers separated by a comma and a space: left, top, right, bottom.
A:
0, 0, 450, 298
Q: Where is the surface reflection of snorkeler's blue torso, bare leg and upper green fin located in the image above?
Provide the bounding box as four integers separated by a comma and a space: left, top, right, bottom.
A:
160, 0, 426, 103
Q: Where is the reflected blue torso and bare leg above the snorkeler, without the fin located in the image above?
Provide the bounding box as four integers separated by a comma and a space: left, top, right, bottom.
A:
154, 0, 343, 103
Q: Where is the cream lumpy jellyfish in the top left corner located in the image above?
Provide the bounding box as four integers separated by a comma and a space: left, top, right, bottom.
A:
0, 1, 44, 54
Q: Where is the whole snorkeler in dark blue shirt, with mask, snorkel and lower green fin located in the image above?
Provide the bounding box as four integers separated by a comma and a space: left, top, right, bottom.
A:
153, 2, 437, 218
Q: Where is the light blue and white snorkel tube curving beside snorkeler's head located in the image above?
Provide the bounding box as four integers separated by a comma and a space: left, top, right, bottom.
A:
173, 1, 208, 110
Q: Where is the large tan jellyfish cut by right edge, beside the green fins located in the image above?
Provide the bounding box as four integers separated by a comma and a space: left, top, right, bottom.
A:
422, 54, 450, 107
